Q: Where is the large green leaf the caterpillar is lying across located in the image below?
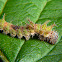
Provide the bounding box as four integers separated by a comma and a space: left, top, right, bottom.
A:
0, 0, 62, 62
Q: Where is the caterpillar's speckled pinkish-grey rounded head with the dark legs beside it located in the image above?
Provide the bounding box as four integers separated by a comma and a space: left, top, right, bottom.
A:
39, 31, 58, 44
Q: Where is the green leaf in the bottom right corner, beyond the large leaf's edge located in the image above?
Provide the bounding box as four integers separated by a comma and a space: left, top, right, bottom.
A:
37, 38, 62, 62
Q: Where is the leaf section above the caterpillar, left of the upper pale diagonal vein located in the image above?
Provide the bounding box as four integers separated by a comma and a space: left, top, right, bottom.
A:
4, 0, 47, 25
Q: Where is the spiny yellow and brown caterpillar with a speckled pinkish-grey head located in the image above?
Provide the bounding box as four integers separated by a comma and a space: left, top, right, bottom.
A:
0, 15, 58, 44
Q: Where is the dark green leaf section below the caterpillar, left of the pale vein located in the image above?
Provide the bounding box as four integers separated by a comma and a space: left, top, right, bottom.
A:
0, 33, 24, 62
